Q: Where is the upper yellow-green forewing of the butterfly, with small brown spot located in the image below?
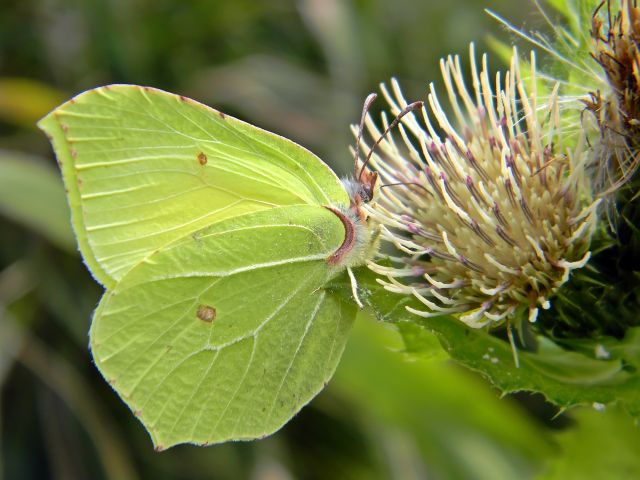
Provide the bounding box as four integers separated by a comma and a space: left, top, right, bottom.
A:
39, 85, 349, 286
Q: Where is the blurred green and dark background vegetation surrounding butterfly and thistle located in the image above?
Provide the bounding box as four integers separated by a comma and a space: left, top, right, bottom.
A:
0, 0, 640, 480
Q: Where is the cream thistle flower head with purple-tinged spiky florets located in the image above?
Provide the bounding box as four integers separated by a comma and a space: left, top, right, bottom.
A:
362, 46, 597, 327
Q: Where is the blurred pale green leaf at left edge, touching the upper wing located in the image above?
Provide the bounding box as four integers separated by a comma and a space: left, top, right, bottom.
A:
0, 150, 76, 251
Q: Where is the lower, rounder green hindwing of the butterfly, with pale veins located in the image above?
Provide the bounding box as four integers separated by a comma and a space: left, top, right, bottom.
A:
91, 206, 356, 449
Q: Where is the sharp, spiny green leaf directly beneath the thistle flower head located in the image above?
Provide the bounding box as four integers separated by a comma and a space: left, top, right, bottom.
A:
334, 269, 640, 416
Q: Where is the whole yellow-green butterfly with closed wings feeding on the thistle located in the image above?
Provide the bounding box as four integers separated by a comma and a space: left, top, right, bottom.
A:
39, 85, 400, 449
